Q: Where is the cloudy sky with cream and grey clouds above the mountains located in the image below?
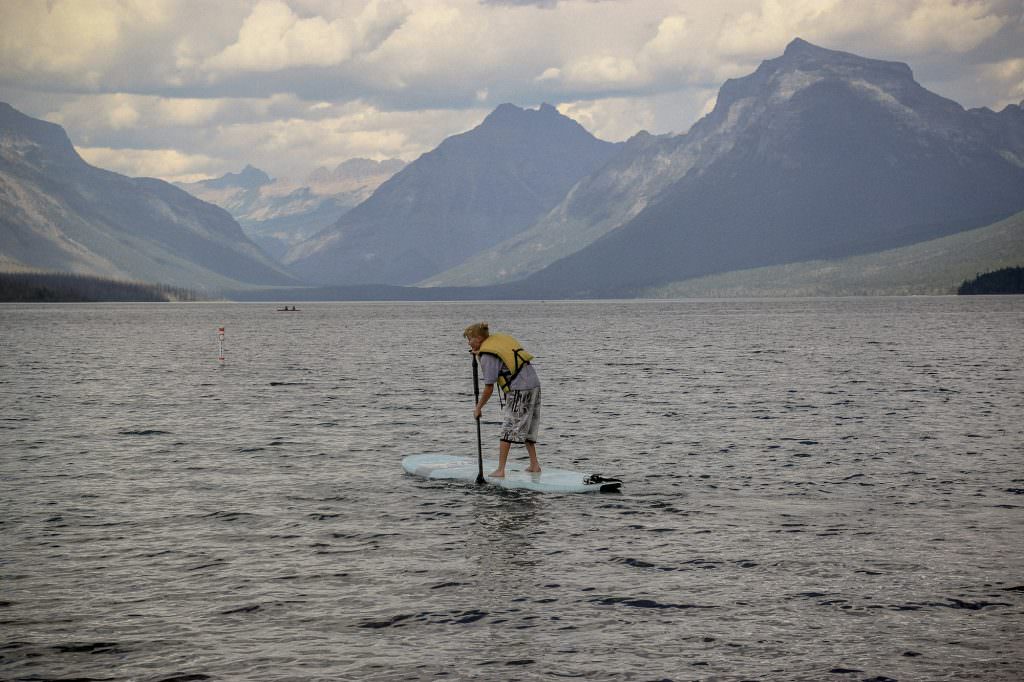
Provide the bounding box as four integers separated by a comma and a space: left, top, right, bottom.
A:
0, 0, 1024, 180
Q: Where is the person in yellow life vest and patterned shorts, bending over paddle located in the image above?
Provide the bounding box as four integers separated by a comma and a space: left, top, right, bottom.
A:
462, 323, 541, 478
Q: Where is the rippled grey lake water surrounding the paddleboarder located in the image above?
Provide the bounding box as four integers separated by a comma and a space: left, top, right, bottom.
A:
0, 297, 1024, 681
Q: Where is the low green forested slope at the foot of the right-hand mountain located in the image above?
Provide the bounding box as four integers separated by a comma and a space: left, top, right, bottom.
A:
639, 205, 1024, 298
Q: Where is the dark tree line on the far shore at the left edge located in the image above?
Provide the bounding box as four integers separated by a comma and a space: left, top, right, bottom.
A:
0, 272, 200, 303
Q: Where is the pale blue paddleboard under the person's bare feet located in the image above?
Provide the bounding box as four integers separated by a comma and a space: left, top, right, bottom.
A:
401, 455, 622, 493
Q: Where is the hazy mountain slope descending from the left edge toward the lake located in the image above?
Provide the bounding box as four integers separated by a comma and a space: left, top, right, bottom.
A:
0, 103, 294, 289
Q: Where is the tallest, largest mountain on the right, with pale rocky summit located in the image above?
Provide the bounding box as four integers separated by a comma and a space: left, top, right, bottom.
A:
507, 39, 1024, 296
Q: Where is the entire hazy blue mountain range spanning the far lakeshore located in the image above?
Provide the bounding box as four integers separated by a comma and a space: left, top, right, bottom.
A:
0, 39, 1024, 298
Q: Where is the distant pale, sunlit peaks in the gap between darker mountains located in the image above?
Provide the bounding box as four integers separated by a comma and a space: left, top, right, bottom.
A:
178, 159, 406, 259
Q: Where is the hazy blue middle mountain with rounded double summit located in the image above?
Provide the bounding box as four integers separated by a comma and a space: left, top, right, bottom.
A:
286, 104, 616, 284
